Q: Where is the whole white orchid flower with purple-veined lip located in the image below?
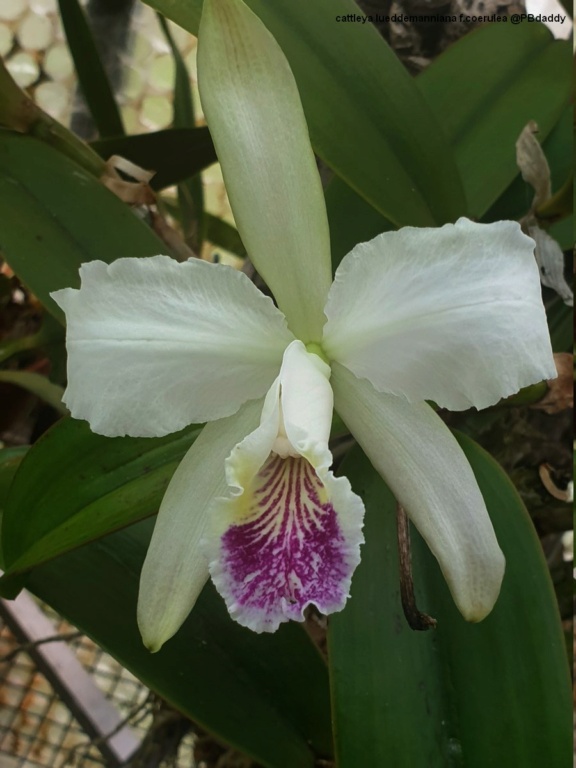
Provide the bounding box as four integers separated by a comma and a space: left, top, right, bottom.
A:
54, 0, 555, 650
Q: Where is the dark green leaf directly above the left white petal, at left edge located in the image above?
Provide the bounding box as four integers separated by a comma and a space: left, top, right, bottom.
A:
0, 131, 166, 322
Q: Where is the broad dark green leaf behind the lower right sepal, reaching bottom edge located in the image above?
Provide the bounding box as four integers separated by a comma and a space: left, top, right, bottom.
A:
329, 436, 572, 768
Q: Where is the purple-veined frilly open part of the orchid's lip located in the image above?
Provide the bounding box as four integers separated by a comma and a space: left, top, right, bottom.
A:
216, 454, 352, 631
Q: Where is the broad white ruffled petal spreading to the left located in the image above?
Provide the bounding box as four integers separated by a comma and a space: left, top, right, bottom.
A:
52, 256, 293, 437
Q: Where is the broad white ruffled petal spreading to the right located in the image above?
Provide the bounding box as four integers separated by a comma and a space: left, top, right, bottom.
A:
322, 219, 556, 410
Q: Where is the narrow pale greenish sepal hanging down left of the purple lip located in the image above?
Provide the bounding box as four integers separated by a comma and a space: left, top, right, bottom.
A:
138, 400, 262, 651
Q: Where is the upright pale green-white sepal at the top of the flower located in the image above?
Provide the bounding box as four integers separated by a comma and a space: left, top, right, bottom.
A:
198, 0, 331, 342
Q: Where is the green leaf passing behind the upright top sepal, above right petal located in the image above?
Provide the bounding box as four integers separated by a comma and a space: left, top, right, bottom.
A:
146, 0, 466, 225
